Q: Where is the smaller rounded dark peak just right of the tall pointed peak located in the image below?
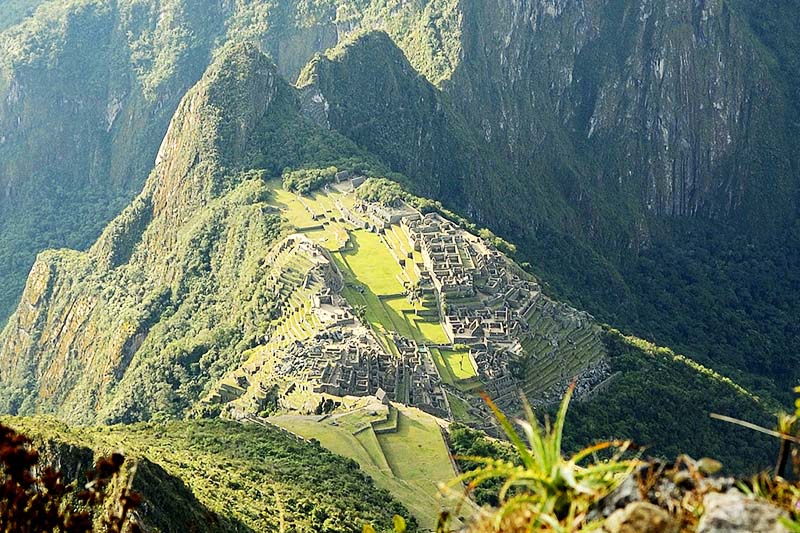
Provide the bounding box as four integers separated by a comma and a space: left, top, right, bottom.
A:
298, 32, 483, 203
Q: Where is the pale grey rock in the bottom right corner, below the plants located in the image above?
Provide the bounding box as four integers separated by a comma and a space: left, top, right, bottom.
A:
697, 491, 789, 533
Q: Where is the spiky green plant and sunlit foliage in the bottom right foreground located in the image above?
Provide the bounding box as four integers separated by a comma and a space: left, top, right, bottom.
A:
441, 386, 800, 533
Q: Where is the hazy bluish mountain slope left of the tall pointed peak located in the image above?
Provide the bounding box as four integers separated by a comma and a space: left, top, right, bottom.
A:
0, 1, 228, 315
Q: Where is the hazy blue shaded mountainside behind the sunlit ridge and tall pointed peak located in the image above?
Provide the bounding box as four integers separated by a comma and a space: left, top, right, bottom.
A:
0, 0, 800, 412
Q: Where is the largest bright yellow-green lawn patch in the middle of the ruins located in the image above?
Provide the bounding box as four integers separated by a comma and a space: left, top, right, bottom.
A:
342, 230, 405, 296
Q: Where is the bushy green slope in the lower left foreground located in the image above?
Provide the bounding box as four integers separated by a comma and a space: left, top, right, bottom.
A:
6, 418, 414, 533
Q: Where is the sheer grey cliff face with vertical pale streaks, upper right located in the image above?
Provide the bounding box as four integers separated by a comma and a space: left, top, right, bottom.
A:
445, 0, 797, 243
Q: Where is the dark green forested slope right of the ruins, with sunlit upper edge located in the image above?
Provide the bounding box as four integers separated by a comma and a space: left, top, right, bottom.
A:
565, 330, 772, 474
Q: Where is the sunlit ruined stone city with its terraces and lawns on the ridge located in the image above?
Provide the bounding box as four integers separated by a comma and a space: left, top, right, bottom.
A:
206, 177, 608, 423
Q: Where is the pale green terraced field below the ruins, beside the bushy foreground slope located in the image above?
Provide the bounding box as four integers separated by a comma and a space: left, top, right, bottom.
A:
270, 407, 455, 529
